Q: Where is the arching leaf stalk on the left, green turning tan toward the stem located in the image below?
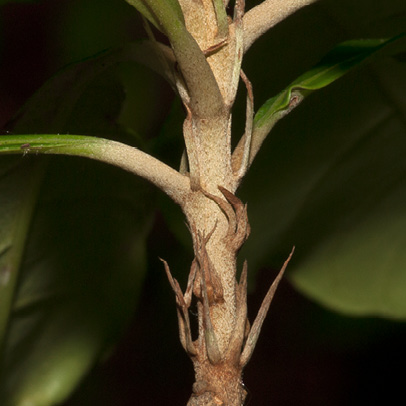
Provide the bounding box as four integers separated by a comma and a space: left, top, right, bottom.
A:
0, 134, 190, 203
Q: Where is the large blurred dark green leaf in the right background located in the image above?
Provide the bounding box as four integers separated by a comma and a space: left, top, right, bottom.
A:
239, 54, 406, 320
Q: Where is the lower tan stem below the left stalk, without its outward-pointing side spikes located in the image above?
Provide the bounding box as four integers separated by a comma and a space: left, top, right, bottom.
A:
184, 191, 249, 406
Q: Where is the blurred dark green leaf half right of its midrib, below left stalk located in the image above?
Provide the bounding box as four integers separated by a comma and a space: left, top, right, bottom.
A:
0, 154, 152, 406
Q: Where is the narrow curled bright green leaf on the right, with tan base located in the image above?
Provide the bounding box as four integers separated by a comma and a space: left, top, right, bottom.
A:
250, 34, 405, 162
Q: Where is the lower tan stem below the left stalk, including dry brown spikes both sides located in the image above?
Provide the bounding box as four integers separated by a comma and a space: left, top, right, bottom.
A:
165, 170, 290, 406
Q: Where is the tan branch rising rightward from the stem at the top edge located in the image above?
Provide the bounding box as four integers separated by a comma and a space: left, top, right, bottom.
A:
243, 0, 317, 53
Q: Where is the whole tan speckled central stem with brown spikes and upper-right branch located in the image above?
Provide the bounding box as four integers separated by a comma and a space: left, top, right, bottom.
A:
158, 0, 302, 406
